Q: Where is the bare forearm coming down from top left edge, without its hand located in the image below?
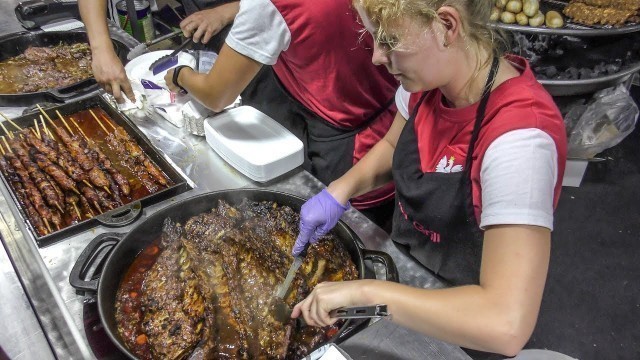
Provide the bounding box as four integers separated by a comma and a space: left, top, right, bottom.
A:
78, 0, 114, 52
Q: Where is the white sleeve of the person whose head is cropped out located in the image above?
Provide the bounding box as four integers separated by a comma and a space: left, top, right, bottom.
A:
225, 0, 291, 65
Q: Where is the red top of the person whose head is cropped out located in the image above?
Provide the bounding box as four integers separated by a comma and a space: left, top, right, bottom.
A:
272, 0, 398, 208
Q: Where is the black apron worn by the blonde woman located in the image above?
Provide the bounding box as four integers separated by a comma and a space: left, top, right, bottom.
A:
391, 57, 499, 285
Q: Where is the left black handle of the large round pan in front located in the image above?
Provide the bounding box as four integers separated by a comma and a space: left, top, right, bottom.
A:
69, 233, 126, 292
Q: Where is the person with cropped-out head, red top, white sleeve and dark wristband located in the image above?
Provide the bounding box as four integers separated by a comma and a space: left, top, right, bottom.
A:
170, 0, 398, 230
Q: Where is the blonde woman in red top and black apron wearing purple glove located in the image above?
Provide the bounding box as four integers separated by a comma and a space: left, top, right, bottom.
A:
292, 0, 567, 356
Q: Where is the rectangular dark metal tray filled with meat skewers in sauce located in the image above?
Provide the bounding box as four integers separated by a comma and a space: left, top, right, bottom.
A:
0, 95, 191, 247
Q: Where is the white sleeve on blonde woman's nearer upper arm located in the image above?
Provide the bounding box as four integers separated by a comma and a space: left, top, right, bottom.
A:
480, 128, 558, 230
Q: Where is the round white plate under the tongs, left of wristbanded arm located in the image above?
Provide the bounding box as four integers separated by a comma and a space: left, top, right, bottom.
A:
124, 50, 196, 93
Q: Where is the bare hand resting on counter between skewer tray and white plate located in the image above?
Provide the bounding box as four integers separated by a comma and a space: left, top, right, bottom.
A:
91, 50, 136, 103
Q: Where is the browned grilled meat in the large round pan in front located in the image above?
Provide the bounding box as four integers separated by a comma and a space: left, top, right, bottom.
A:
116, 200, 357, 359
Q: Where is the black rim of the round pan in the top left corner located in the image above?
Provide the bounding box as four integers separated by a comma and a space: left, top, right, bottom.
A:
0, 31, 129, 107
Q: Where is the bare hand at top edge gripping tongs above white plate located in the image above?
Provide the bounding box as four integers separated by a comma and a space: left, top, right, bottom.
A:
180, 7, 230, 44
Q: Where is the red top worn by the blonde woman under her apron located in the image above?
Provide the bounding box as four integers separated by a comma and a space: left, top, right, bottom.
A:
409, 55, 567, 223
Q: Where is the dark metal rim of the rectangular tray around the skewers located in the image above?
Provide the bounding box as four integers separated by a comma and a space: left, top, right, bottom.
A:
0, 94, 192, 247
